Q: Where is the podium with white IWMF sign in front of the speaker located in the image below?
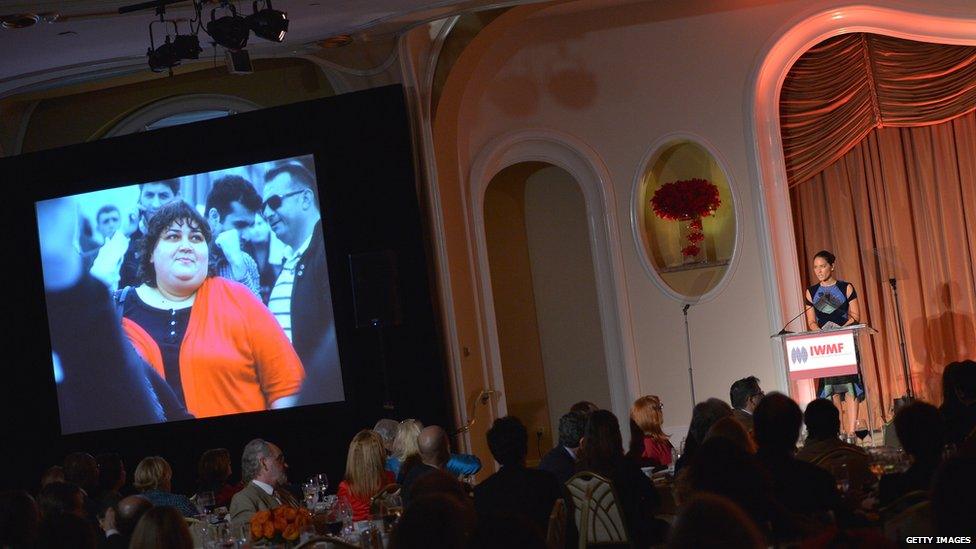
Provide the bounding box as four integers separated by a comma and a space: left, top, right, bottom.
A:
771, 324, 878, 441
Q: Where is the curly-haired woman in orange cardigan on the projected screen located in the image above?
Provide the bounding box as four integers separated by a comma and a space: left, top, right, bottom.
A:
120, 200, 305, 417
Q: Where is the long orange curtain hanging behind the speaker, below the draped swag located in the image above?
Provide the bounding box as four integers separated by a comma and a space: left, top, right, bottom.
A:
790, 112, 976, 420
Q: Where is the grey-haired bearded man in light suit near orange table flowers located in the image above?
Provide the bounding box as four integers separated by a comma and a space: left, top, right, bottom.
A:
230, 438, 300, 525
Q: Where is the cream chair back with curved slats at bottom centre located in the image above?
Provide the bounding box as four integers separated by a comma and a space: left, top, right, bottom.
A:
566, 471, 630, 549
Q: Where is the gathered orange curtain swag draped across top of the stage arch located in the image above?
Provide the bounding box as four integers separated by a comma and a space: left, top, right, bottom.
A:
780, 33, 976, 186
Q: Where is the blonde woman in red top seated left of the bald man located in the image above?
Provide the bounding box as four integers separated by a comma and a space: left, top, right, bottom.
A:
338, 429, 394, 521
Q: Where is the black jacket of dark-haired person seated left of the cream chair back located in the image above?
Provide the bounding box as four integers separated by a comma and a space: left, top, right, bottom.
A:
474, 465, 563, 535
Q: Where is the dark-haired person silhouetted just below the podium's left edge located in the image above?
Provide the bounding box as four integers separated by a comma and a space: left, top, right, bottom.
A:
753, 393, 840, 517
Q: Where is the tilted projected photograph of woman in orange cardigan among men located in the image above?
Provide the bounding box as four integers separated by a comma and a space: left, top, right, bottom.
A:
36, 155, 344, 434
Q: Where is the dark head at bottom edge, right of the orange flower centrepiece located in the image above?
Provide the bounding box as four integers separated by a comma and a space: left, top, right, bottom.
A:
390, 494, 474, 549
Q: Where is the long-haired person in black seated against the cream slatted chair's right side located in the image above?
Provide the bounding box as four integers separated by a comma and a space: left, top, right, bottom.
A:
576, 410, 663, 547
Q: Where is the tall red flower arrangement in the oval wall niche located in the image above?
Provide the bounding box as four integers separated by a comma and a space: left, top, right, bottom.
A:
651, 178, 722, 257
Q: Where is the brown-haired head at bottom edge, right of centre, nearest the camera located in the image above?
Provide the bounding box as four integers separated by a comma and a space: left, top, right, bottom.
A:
667, 493, 768, 549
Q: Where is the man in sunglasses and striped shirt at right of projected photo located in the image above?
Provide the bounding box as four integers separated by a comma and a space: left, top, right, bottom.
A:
261, 162, 343, 404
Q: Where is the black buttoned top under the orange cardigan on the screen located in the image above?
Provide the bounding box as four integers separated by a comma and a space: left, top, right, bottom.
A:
122, 291, 193, 406
